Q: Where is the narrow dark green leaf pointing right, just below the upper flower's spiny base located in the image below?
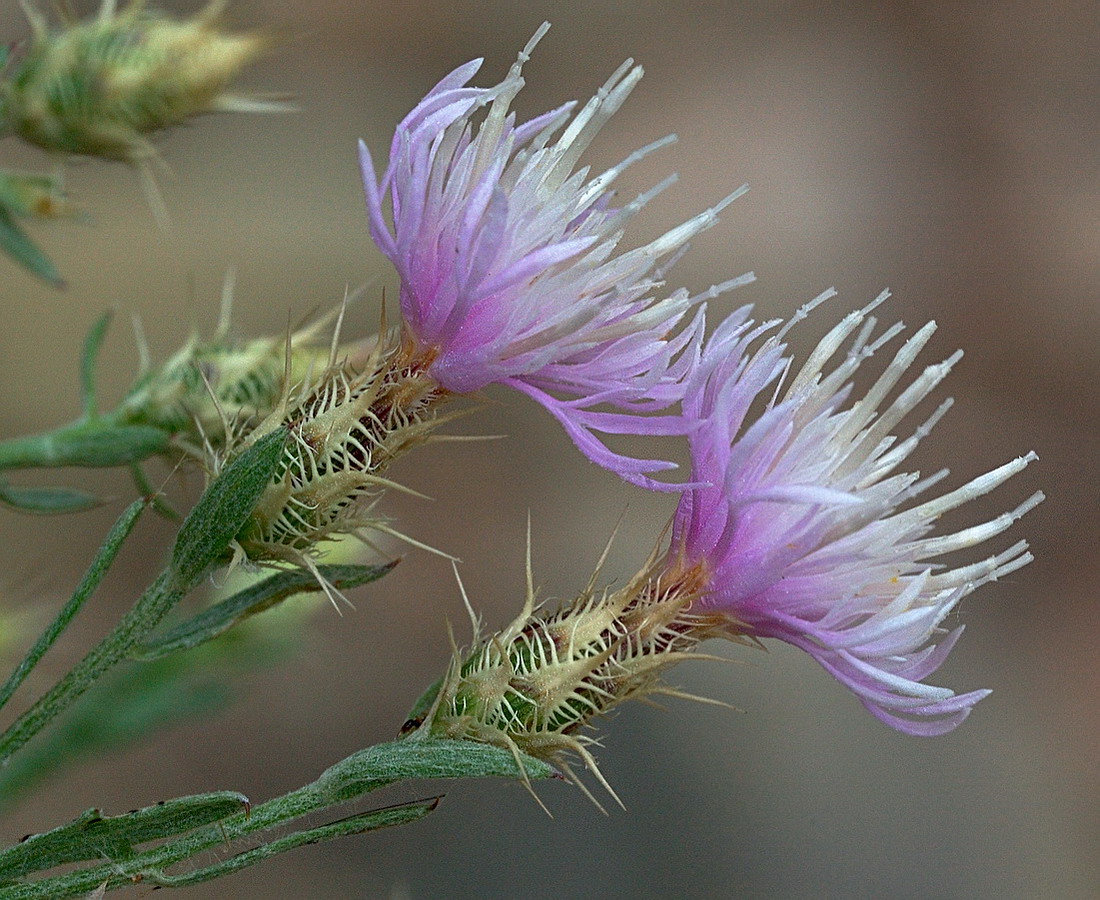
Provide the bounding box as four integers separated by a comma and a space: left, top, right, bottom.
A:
130, 560, 397, 661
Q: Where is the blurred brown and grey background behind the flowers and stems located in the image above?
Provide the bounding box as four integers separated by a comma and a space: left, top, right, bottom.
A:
0, 0, 1100, 898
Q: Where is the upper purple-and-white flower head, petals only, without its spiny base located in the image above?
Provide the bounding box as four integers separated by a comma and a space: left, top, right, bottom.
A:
361, 24, 752, 487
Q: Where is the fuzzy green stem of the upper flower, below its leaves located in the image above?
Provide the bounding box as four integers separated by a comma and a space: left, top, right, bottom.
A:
0, 570, 186, 767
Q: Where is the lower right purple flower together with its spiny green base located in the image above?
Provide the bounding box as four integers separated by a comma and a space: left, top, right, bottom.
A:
407, 292, 1043, 795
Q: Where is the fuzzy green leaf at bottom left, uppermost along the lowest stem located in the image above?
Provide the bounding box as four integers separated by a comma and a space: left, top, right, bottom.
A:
0, 791, 251, 880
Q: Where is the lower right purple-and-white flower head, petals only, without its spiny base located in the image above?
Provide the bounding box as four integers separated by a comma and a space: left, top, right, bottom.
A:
668, 292, 1043, 735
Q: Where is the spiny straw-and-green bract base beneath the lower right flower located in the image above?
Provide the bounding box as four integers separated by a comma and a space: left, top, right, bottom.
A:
403, 560, 733, 800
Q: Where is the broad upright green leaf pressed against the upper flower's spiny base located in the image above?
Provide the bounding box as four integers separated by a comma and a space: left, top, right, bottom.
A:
171, 428, 286, 591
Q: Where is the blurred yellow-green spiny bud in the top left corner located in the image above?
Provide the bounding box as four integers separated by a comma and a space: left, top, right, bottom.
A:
0, 0, 279, 163
